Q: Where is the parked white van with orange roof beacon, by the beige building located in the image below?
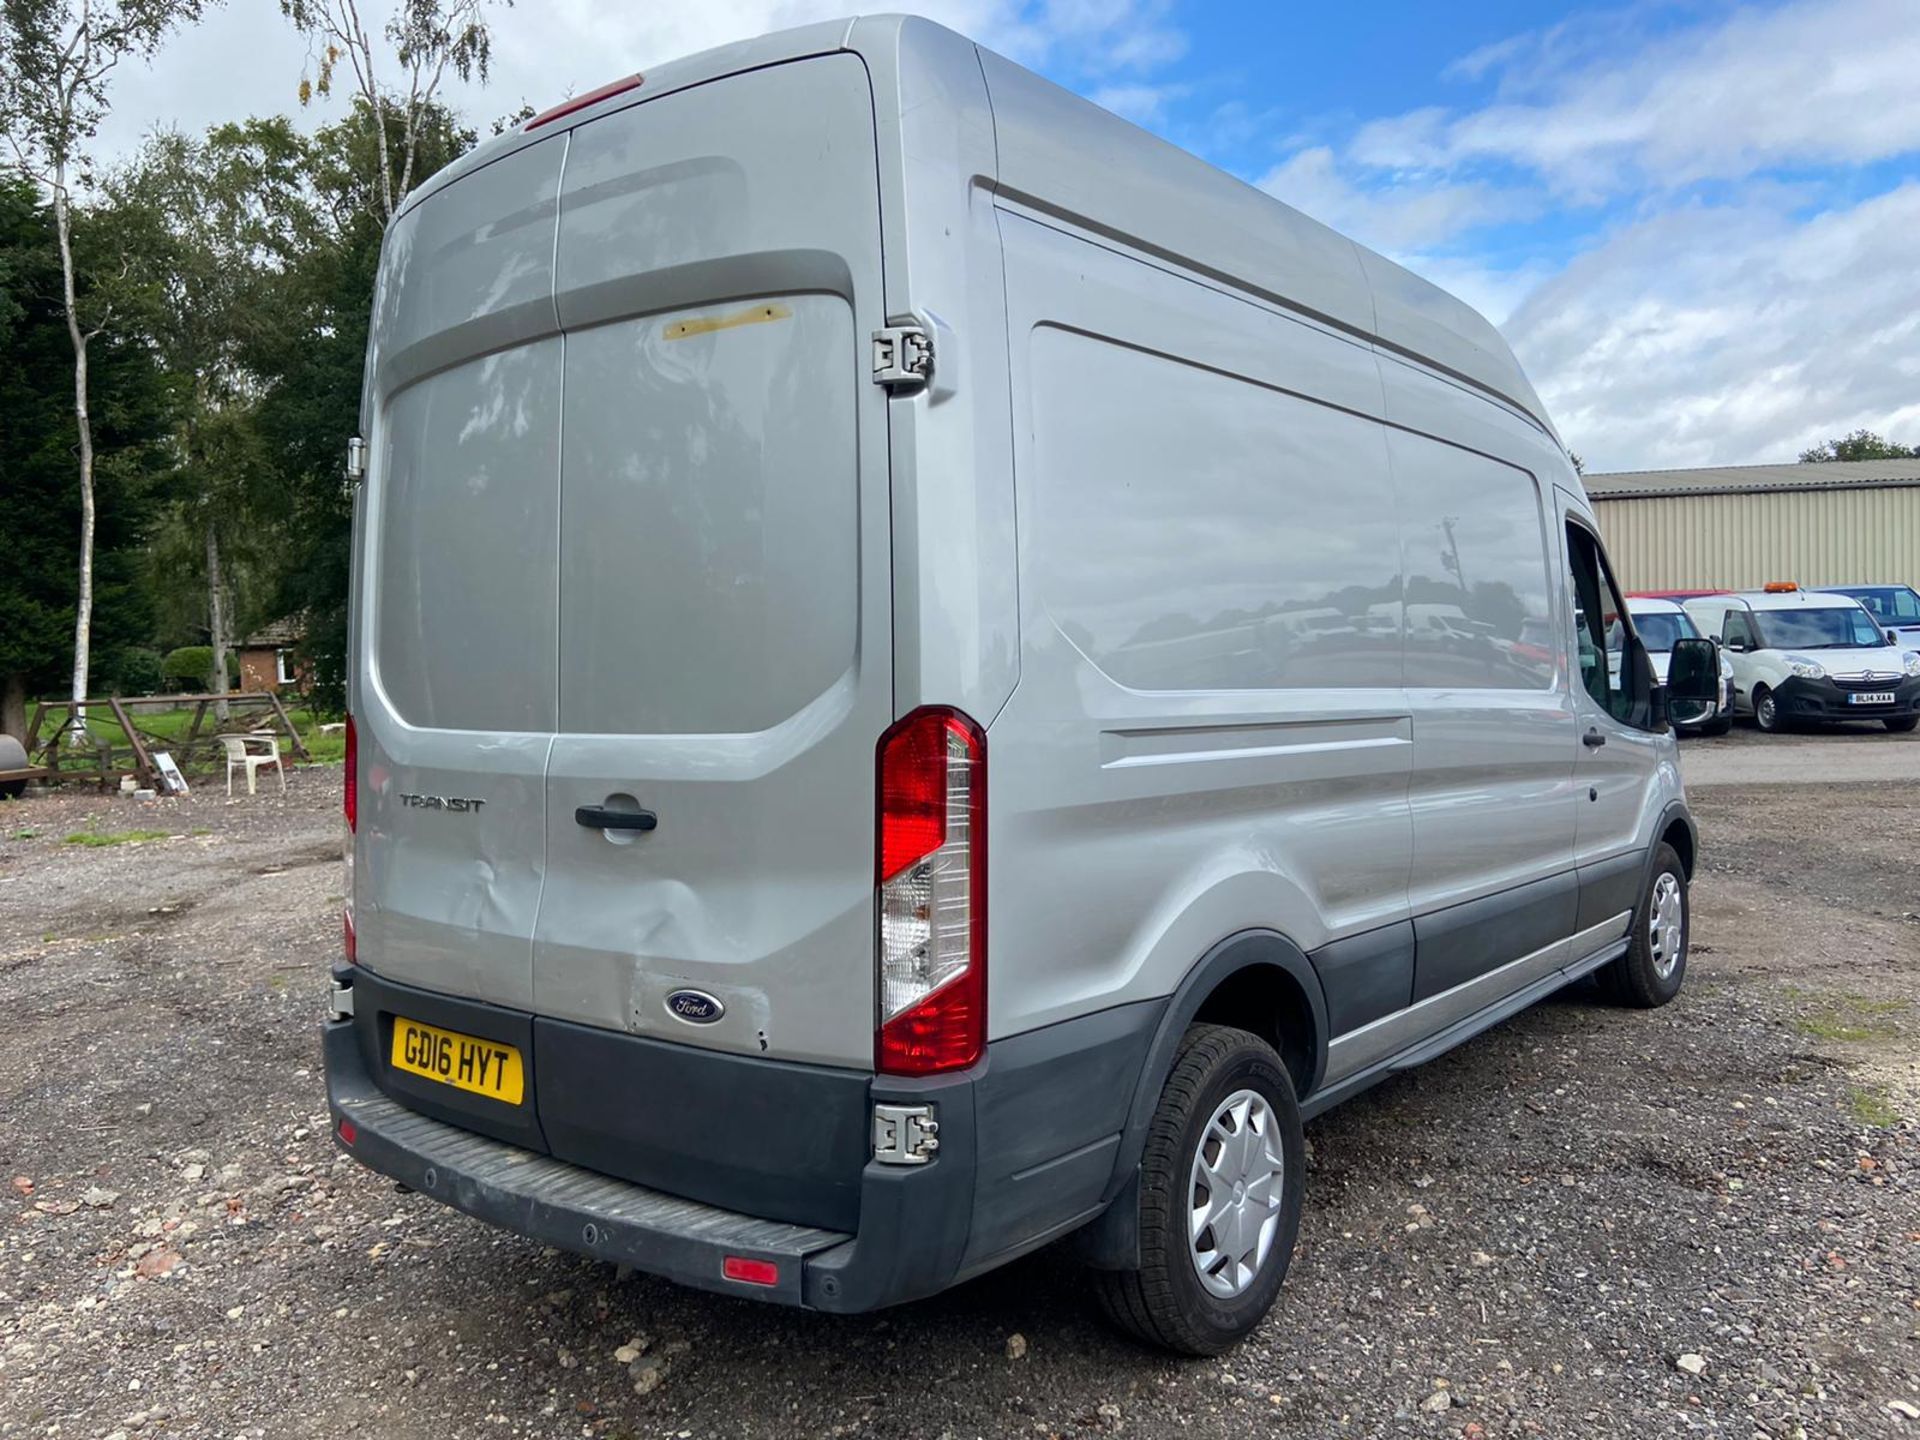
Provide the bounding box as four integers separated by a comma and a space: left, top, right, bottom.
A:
1686, 584, 1920, 733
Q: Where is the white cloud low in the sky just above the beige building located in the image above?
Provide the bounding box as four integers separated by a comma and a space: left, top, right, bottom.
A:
1505, 180, 1920, 470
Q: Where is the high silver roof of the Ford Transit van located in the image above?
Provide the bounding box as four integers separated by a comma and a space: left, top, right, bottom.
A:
405, 15, 1559, 444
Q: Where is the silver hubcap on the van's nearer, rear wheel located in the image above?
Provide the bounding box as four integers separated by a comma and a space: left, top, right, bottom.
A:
1187, 1091, 1286, 1300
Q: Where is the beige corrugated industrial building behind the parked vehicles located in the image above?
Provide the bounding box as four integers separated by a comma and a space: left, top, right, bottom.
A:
1586, 459, 1920, 589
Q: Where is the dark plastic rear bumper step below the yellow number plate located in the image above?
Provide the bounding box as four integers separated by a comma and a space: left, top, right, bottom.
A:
326, 1023, 852, 1306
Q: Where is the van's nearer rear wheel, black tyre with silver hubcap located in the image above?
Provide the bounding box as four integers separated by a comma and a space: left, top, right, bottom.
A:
1094, 1025, 1306, 1356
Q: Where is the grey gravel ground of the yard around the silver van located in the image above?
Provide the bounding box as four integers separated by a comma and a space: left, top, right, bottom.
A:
0, 756, 1920, 1440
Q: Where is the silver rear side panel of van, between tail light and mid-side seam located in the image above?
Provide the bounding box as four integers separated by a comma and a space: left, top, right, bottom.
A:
989, 207, 1411, 1039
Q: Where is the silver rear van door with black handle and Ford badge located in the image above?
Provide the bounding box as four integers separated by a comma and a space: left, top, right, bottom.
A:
534, 54, 893, 1069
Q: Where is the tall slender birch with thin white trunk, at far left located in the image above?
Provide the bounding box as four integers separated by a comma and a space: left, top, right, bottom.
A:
0, 0, 202, 745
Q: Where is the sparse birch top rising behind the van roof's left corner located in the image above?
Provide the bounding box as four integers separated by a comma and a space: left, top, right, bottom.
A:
280, 0, 513, 227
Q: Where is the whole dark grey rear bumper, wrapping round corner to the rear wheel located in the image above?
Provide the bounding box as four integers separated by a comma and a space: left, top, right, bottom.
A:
324, 973, 1164, 1313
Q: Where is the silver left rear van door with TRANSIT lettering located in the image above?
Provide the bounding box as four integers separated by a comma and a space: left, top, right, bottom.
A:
351, 136, 566, 1021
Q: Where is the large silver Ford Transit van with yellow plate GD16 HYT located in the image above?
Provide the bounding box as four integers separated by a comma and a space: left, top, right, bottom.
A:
326, 17, 1715, 1354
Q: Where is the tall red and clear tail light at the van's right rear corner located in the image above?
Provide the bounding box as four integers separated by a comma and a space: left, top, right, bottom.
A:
874, 707, 987, 1075
